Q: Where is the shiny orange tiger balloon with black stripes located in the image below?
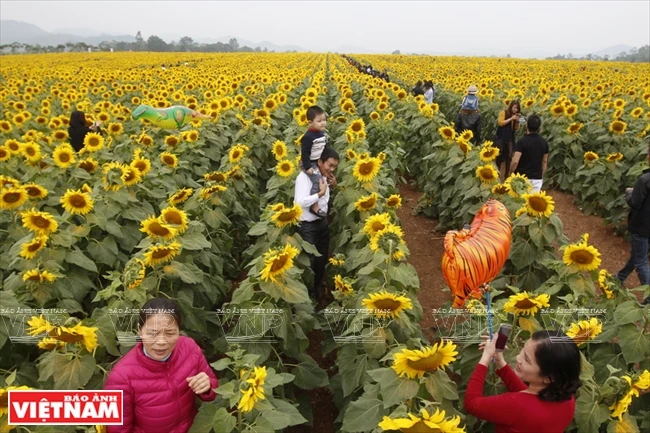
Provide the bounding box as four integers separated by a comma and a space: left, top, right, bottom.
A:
442, 199, 512, 308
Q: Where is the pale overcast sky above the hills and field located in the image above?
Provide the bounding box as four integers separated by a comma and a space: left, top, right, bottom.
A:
0, 0, 650, 57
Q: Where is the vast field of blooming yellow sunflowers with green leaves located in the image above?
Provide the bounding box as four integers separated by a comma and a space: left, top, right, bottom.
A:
0, 53, 650, 433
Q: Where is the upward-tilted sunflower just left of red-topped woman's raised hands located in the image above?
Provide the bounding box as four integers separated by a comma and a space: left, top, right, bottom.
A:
392, 341, 458, 379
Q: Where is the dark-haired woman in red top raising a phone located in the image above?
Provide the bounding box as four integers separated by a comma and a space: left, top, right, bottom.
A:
465, 331, 581, 433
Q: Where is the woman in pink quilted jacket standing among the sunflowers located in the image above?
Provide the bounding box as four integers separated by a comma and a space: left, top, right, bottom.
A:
104, 298, 218, 433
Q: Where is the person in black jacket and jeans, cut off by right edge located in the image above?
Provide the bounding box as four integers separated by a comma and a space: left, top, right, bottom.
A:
616, 147, 650, 304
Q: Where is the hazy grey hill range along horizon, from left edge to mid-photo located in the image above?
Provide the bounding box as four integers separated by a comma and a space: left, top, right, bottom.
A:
0, 20, 308, 52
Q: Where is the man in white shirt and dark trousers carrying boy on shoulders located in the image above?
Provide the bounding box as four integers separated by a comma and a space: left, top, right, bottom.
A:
293, 147, 339, 300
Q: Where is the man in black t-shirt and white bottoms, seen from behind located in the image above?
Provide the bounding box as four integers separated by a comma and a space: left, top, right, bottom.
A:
510, 114, 548, 192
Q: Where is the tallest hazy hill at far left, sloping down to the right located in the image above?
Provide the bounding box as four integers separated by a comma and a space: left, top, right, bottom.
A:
0, 20, 135, 46
